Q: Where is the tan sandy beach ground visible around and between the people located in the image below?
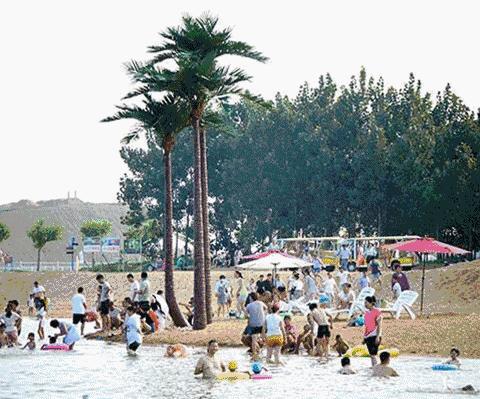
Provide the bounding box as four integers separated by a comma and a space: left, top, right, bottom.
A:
0, 261, 480, 358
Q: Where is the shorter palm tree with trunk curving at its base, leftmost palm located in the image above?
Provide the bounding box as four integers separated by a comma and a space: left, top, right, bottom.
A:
102, 94, 189, 327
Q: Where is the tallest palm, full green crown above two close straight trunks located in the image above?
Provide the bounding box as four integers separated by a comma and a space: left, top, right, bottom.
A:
145, 14, 267, 328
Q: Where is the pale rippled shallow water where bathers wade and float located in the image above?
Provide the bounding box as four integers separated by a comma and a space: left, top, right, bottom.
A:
0, 320, 480, 399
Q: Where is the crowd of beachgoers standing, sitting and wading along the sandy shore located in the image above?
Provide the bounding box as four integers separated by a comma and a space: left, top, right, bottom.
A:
0, 262, 468, 390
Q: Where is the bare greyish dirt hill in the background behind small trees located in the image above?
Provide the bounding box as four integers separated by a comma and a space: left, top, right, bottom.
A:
0, 198, 127, 262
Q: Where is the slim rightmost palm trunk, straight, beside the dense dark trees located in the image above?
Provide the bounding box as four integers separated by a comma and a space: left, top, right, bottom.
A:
200, 127, 213, 324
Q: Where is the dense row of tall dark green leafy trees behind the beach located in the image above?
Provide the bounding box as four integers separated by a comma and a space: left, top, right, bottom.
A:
119, 70, 480, 253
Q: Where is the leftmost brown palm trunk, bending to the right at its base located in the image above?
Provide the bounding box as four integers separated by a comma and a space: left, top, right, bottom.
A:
163, 143, 188, 327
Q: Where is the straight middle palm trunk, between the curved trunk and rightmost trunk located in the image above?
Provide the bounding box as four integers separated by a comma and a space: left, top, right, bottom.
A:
192, 117, 207, 330
